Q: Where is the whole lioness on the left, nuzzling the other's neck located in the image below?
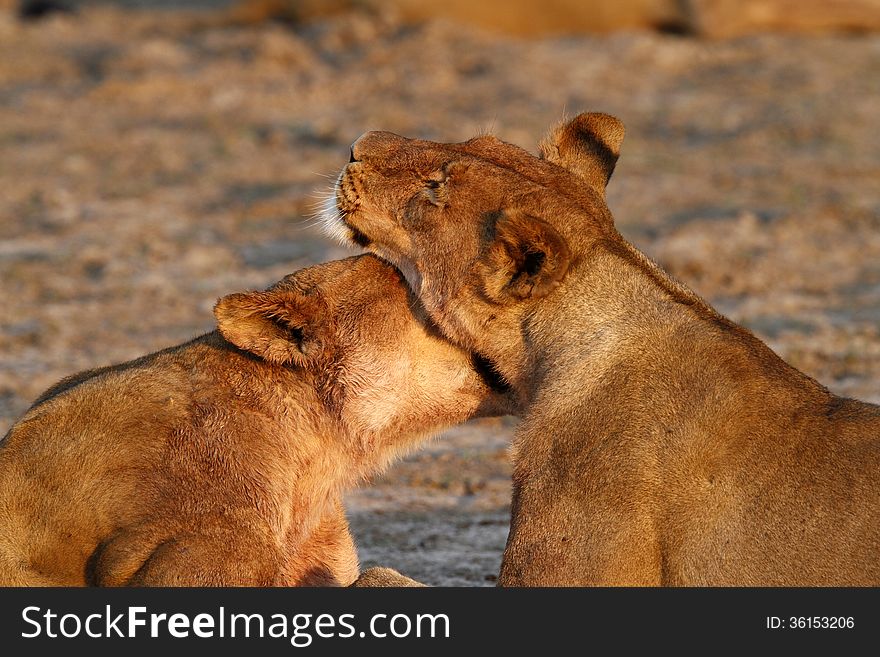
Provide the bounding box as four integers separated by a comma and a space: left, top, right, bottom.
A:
0, 256, 504, 586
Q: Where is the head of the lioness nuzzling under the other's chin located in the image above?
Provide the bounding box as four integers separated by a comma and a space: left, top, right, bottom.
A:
214, 255, 506, 448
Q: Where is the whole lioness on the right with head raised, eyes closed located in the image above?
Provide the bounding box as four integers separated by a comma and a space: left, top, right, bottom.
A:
328, 114, 880, 585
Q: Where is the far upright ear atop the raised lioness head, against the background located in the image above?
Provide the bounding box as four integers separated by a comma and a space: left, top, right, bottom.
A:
540, 112, 626, 198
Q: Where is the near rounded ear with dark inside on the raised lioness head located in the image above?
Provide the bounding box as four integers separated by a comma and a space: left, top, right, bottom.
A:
482, 210, 571, 303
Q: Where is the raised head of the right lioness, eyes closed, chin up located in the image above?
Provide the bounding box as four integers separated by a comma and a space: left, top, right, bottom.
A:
325, 114, 624, 394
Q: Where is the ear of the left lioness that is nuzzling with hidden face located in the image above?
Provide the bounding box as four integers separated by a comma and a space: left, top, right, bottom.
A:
214, 289, 328, 366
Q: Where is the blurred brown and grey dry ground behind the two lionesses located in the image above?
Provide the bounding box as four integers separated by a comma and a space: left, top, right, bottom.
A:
0, 0, 880, 585
